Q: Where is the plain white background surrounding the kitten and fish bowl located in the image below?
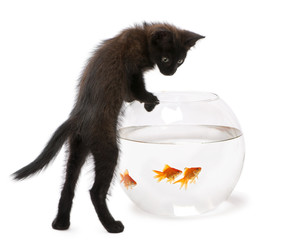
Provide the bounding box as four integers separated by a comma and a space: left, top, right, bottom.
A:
0, 0, 285, 240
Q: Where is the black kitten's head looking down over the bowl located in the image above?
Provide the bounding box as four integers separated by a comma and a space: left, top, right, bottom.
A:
150, 26, 204, 76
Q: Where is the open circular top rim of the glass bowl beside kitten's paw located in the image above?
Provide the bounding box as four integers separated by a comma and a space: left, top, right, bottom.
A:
154, 91, 220, 103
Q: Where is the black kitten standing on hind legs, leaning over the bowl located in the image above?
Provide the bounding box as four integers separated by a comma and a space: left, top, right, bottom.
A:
14, 23, 204, 233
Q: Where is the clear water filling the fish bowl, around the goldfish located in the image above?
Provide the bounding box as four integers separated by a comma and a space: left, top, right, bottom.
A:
119, 125, 244, 216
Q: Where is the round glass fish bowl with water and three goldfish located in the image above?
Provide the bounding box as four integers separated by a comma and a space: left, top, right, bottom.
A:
119, 92, 245, 216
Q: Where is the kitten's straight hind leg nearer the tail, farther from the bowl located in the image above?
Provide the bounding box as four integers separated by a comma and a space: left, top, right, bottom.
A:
52, 135, 88, 230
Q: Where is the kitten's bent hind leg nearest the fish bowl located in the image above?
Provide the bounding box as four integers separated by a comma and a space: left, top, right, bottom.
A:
90, 141, 124, 233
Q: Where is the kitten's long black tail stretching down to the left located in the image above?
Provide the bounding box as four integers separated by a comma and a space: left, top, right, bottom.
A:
12, 119, 72, 180
